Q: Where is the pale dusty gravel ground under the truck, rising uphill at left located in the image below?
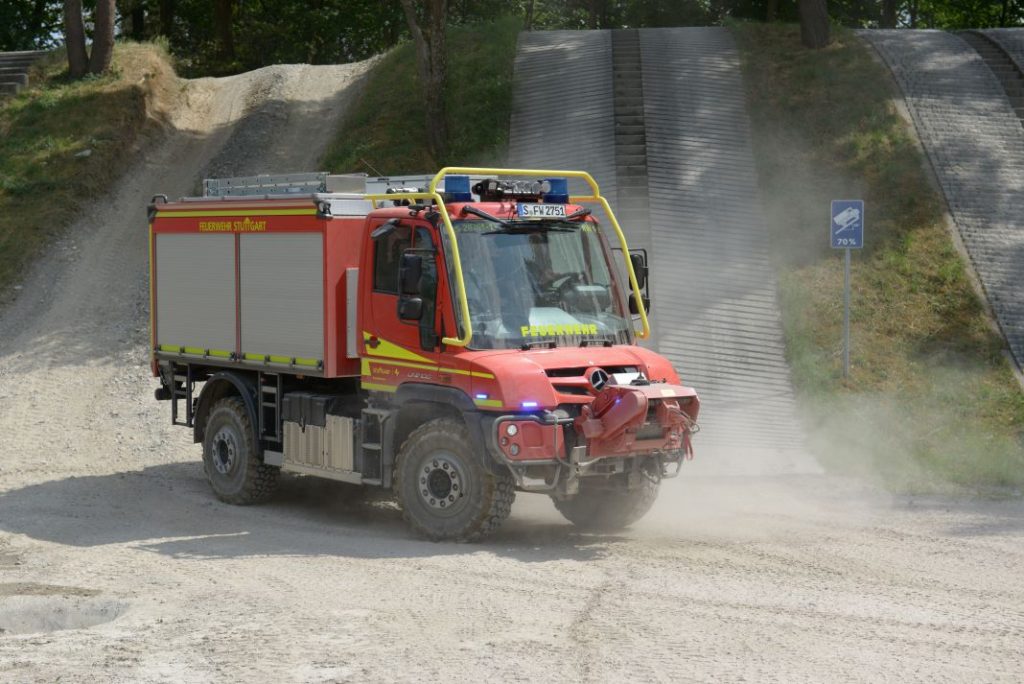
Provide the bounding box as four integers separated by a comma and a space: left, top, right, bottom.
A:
0, 65, 1024, 682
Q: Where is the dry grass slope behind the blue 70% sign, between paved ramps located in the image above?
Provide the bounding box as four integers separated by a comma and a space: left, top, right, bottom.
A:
733, 24, 1024, 490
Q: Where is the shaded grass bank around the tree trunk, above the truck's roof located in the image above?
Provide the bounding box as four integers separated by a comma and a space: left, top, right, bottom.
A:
323, 17, 522, 175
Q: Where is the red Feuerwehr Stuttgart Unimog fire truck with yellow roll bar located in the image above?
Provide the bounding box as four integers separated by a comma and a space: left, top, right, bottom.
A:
150, 168, 698, 541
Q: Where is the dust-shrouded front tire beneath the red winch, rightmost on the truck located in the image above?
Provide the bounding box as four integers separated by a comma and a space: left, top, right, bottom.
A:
553, 477, 660, 531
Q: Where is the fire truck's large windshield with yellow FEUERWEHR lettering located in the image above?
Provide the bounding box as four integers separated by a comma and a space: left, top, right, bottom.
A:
449, 220, 632, 349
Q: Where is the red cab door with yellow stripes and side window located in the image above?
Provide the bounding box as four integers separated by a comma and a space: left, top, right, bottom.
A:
361, 219, 440, 391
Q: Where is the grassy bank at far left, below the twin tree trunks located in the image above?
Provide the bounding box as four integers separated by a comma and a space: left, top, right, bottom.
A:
0, 43, 174, 294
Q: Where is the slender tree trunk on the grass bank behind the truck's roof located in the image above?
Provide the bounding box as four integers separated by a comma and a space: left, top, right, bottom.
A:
401, 0, 447, 160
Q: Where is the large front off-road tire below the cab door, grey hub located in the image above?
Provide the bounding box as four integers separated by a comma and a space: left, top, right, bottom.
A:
395, 418, 515, 542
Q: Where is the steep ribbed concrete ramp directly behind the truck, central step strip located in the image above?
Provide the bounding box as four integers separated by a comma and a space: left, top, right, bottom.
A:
509, 28, 818, 475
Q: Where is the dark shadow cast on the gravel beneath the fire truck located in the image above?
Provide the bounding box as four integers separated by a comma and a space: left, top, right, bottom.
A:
0, 463, 626, 562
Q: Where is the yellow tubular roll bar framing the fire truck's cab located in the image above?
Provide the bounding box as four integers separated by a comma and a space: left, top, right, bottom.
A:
366, 166, 650, 347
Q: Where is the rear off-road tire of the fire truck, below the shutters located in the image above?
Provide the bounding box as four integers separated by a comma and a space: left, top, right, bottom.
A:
203, 396, 281, 506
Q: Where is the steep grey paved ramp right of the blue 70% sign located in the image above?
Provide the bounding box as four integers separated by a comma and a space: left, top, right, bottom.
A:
858, 29, 1024, 367
